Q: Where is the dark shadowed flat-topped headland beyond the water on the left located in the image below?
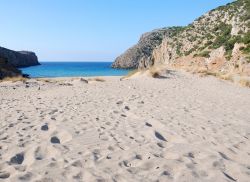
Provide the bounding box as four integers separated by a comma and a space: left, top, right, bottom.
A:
0, 47, 39, 67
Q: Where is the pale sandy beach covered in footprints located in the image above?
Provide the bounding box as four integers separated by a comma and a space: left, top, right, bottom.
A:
0, 71, 250, 182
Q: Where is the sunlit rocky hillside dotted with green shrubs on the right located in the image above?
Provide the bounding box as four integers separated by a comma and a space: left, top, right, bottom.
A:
112, 0, 250, 76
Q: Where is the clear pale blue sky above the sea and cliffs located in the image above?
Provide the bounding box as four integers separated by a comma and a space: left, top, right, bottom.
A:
0, 0, 232, 61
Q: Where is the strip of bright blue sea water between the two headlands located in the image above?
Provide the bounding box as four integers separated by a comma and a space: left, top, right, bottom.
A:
21, 62, 129, 78
